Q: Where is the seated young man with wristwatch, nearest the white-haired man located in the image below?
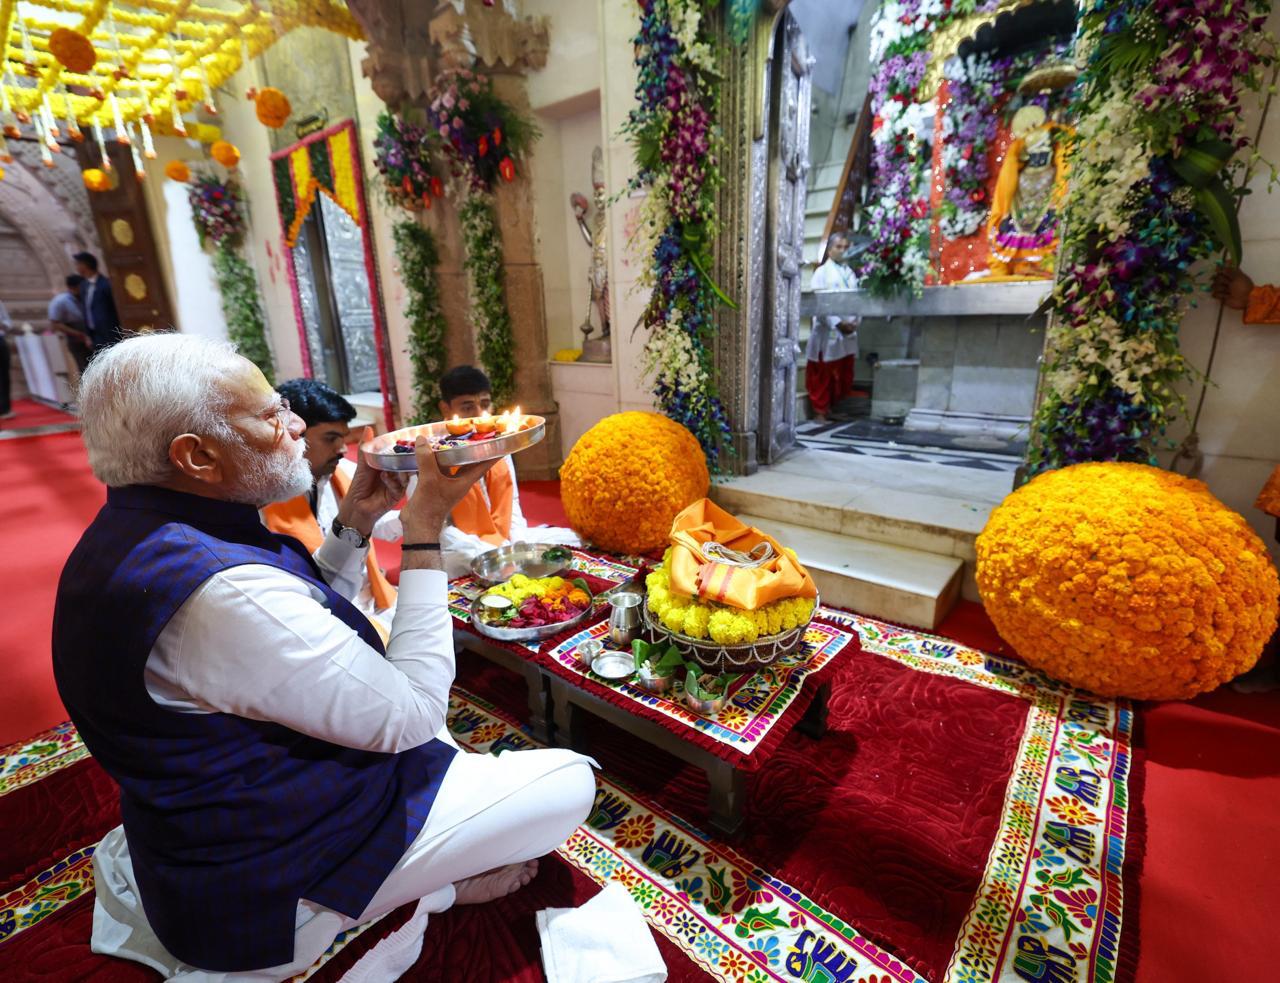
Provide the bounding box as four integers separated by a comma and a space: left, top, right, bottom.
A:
262, 379, 403, 641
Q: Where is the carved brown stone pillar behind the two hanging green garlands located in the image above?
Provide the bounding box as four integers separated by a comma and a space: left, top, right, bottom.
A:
348, 0, 561, 479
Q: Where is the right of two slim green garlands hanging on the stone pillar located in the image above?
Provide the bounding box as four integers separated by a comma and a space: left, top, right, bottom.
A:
458, 191, 516, 406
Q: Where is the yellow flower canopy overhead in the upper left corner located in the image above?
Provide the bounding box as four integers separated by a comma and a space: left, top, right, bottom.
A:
0, 0, 362, 142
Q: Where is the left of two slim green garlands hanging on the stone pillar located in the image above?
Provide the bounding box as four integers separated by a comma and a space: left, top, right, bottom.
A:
392, 220, 447, 425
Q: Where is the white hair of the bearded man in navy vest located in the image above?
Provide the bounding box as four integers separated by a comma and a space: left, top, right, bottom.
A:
79, 334, 244, 488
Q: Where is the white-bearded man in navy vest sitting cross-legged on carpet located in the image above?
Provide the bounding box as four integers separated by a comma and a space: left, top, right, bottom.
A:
54, 334, 595, 980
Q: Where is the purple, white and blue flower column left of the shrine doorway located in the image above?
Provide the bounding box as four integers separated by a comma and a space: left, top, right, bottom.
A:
625, 0, 732, 471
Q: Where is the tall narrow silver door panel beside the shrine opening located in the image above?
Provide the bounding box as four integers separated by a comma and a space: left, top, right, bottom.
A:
758, 12, 813, 463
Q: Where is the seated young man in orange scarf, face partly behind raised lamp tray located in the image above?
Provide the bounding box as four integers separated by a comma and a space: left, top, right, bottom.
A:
440, 365, 581, 577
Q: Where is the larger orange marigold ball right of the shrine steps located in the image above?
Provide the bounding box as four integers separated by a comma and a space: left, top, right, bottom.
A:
978, 463, 1280, 700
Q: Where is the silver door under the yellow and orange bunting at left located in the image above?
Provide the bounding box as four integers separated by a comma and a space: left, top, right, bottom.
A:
293, 192, 381, 393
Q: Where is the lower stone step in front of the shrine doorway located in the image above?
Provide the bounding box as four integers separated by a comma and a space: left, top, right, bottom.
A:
739, 515, 964, 631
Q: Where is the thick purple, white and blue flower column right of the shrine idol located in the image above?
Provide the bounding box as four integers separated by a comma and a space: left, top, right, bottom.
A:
1028, 0, 1275, 472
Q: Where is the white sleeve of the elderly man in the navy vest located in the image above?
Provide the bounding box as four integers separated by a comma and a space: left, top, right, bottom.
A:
145, 564, 454, 751
